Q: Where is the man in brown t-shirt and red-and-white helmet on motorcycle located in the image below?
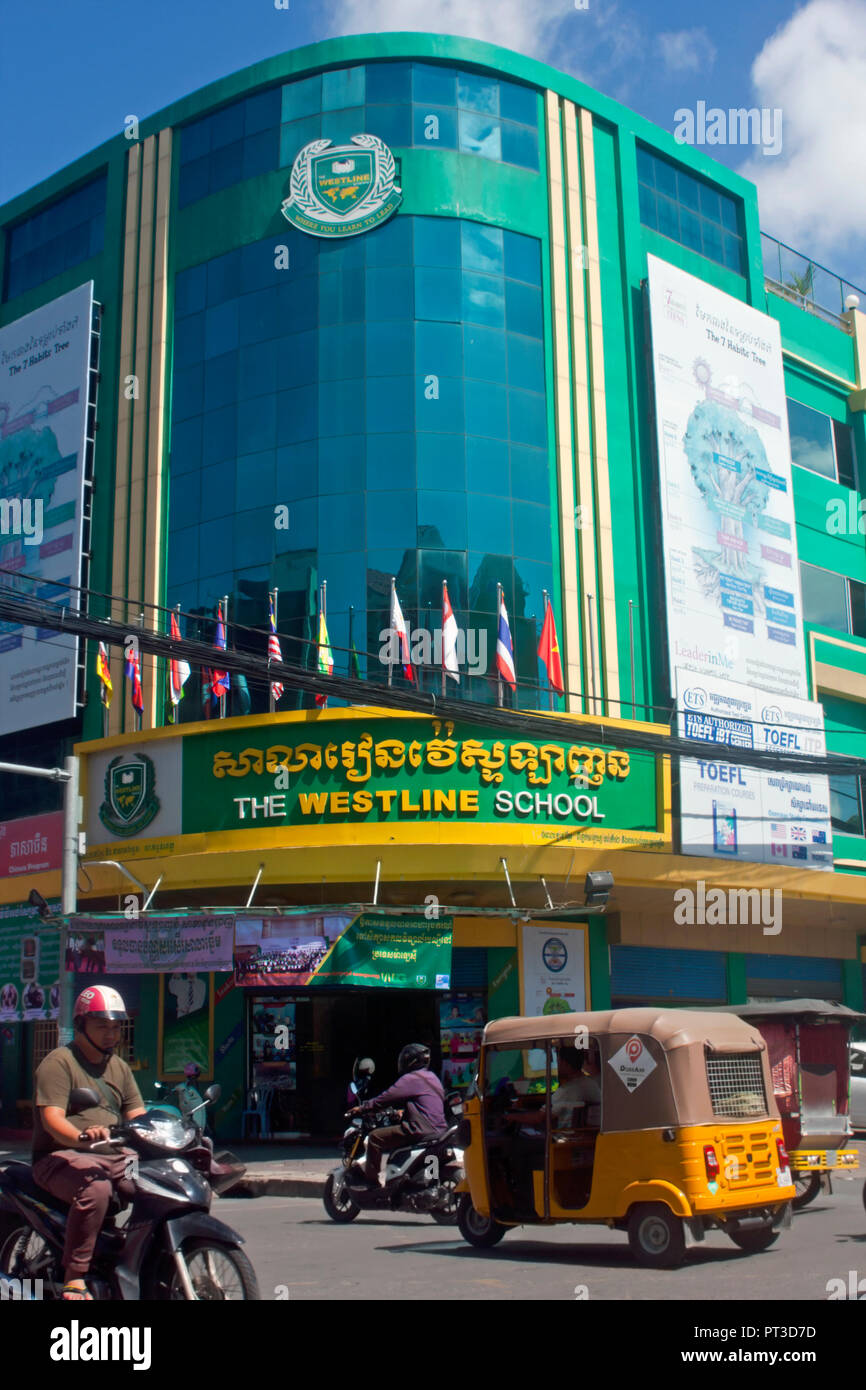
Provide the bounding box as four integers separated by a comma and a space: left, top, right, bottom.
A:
32, 984, 146, 1301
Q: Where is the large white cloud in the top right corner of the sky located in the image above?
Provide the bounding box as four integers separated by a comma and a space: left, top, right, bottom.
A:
740, 0, 866, 273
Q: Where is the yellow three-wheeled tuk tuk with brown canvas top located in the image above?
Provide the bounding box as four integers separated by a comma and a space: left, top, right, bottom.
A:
459, 1008, 794, 1269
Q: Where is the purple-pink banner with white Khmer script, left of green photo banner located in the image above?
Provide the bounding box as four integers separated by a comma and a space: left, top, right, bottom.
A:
70, 916, 235, 974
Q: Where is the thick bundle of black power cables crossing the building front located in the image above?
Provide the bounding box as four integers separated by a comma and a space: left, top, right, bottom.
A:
0, 585, 866, 777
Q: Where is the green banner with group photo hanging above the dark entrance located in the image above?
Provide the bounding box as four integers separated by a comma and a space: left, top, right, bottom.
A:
236, 913, 453, 990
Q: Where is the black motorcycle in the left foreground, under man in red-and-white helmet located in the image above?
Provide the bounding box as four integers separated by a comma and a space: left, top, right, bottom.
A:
0, 1086, 260, 1302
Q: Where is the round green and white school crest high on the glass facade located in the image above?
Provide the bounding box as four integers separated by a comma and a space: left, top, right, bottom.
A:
282, 135, 403, 236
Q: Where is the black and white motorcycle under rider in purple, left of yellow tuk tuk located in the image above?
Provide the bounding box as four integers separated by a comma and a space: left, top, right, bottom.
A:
322, 1056, 463, 1226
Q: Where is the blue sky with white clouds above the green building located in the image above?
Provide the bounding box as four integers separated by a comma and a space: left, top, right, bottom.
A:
0, 0, 866, 287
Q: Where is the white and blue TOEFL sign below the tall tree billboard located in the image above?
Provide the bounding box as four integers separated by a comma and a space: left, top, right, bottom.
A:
677, 671, 833, 869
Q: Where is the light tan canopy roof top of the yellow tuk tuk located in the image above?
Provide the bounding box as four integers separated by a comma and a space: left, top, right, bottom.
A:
484, 1008, 765, 1052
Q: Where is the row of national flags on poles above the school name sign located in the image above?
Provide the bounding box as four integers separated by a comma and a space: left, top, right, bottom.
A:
96, 580, 566, 723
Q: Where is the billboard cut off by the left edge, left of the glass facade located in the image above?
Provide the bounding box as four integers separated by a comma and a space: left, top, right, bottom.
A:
0, 281, 93, 735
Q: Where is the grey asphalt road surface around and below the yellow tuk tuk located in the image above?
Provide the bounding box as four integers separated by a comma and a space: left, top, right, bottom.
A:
222, 1145, 866, 1302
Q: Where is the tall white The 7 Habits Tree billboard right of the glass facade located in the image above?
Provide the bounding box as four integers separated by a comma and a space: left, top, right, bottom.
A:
648, 256, 808, 699
